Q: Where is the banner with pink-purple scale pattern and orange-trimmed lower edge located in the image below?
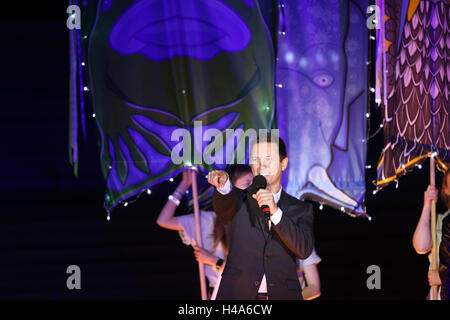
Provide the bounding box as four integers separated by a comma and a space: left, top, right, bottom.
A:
377, 0, 450, 188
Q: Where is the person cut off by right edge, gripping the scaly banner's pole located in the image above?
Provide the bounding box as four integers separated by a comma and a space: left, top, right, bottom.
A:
412, 170, 450, 300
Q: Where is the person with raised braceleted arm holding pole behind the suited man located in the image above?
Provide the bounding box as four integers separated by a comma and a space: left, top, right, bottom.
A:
156, 164, 253, 297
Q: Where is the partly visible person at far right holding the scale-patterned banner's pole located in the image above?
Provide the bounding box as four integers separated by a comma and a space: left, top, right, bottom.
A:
413, 170, 450, 299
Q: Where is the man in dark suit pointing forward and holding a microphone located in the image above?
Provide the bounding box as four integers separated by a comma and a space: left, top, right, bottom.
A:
208, 133, 314, 300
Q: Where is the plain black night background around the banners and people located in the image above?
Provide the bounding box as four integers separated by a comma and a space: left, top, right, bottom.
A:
0, 1, 442, 300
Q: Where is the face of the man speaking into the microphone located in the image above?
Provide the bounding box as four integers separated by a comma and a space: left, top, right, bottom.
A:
250, 142, 288, 186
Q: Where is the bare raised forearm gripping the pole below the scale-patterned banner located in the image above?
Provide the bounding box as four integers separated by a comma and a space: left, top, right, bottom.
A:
412, 185, 439, 254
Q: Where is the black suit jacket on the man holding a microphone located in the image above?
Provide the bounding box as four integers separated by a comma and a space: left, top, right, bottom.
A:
213, 187, 314, 300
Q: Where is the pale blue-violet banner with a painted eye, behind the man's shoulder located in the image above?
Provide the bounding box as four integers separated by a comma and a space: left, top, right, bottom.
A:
276, 0, 369, 216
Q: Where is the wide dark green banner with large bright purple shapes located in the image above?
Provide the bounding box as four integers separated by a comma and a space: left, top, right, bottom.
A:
69, 0, 275, 210
